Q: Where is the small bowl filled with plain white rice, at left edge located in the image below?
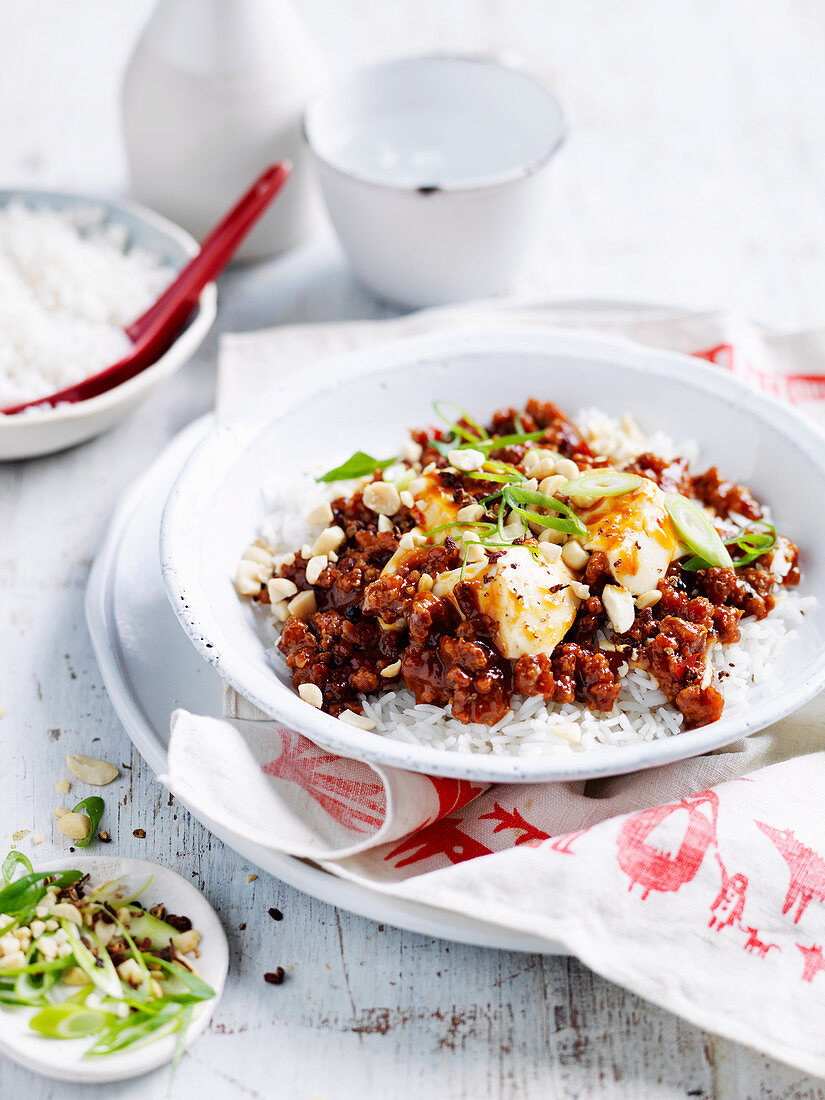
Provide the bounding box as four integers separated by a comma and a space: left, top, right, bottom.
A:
0, 189, 217, 461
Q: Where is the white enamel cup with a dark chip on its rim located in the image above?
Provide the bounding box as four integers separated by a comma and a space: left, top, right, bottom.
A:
305, 57, 564, 307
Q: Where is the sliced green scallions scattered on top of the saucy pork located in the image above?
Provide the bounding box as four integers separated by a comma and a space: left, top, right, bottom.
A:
317, 402, 777, 572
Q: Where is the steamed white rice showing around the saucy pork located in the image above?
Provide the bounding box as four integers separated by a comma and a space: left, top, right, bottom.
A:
251, 408, 816, 756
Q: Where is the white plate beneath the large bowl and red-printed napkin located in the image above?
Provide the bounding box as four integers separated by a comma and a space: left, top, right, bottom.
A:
86, 417, 569, 955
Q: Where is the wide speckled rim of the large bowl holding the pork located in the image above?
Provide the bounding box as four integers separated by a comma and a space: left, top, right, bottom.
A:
161, 327, 825, 782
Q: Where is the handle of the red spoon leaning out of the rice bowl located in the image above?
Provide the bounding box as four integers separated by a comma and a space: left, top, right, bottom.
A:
125, 161, 292, 343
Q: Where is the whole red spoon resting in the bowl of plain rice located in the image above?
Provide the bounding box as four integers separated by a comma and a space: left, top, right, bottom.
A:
0, 161, 293, 416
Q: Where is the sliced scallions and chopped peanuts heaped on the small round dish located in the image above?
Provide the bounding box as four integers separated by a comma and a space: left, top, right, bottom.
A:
0, 851, 216, 1057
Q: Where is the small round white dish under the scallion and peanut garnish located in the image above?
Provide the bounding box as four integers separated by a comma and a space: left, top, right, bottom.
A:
0, 855, 229, 1085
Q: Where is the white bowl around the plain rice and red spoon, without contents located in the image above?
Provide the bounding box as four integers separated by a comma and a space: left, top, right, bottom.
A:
0, 188, 218, 461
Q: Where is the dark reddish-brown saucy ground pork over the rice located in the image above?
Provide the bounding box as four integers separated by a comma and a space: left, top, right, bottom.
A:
247, 400, 800, 728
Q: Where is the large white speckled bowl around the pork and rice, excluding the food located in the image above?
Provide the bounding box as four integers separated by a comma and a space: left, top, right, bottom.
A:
161, 327, 825, 782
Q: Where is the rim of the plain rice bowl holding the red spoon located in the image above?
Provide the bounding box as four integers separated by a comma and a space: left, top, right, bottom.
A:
0, 187, 218, 429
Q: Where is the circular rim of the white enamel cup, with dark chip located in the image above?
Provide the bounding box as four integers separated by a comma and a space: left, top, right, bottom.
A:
301, 54, 568, 198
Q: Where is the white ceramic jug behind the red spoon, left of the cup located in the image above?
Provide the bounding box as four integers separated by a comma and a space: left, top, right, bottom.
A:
122, 0, 326, 260
